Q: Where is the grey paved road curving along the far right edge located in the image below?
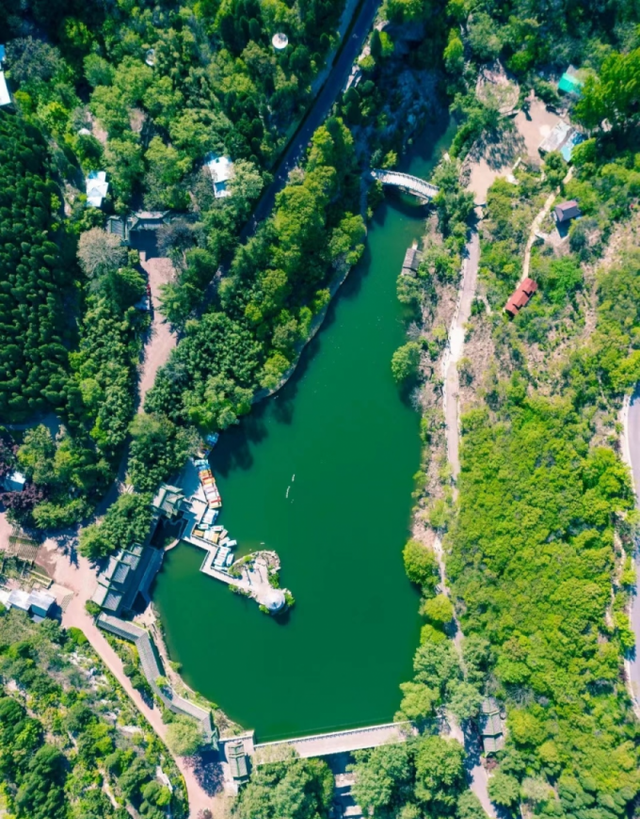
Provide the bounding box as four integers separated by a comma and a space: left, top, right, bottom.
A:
622, 388, 640, 718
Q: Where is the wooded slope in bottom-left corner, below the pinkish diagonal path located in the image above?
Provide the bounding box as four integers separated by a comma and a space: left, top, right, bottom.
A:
0, 609, 188, 819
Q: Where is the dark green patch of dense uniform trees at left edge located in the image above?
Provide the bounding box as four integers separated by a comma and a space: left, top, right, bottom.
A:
0, 112, 70, 421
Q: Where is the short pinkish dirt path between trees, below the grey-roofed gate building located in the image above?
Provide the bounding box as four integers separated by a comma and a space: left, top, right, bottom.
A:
138, 252, 177, 408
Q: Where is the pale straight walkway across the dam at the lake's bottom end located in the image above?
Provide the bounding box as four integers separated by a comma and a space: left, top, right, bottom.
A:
255, 722, 415, 759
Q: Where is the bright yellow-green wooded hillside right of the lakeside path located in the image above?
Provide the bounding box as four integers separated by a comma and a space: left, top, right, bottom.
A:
447, 151, 640, 819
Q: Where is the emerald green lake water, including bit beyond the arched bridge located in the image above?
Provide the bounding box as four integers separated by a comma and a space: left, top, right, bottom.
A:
154, 121, 456, 741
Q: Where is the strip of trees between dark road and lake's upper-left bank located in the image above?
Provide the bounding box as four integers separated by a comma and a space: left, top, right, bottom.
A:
145, 119, 364, 430
